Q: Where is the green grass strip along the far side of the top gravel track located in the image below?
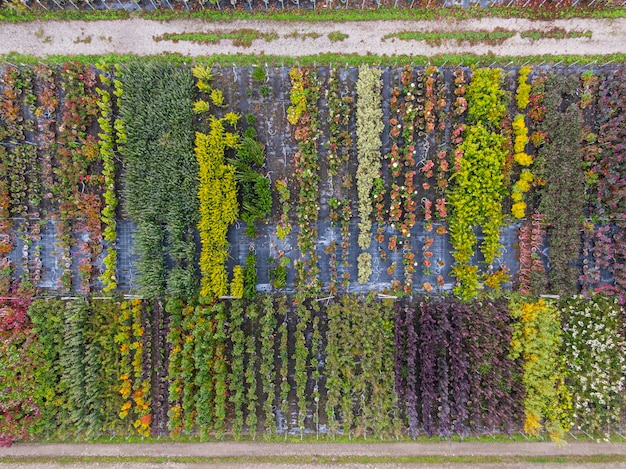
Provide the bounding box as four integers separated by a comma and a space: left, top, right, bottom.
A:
0, 6, 626, 23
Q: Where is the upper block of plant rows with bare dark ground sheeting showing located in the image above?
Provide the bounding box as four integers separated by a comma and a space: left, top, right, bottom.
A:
0, 61, 626, 302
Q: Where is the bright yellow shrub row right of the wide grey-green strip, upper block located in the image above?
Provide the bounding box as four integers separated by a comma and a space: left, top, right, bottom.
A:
195, 118, 239, 297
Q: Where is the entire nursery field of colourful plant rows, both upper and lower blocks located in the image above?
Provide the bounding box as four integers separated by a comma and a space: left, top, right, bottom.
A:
0, 18, 626, 445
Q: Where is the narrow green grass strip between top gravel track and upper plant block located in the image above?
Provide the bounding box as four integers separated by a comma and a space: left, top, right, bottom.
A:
0, 54, 626, 67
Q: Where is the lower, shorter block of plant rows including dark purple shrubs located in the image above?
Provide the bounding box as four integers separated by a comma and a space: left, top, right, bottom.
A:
0, 295, 626, 444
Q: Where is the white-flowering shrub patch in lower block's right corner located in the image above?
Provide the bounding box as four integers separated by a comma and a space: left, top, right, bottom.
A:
560, 295, 626, 438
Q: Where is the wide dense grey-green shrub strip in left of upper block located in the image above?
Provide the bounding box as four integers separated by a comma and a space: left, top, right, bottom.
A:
120, 62, 199, 300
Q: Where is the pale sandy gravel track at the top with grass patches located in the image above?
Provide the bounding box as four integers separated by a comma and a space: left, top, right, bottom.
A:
0, 18, 626, 57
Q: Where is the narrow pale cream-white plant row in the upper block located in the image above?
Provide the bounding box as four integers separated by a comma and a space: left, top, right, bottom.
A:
356, 65, 384, 283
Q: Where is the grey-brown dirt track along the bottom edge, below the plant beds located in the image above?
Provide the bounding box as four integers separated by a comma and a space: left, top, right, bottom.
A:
0, 442, 626, 468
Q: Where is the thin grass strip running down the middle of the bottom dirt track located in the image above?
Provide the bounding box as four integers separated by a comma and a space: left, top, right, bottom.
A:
0, 454, 626, 465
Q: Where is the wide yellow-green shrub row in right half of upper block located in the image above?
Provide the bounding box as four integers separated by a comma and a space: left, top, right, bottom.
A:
448, 69, 508, 299
